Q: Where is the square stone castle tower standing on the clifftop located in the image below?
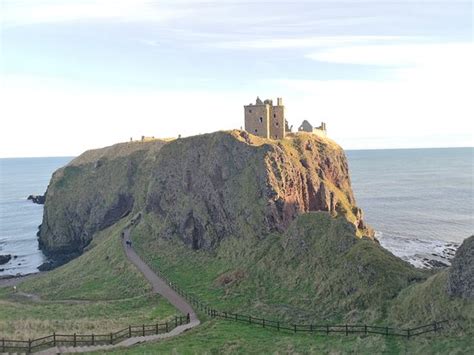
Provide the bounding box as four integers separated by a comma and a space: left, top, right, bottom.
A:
244, 97, 286, 139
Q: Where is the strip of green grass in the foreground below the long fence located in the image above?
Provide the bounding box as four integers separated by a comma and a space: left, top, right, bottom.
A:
98, 320, 474, 355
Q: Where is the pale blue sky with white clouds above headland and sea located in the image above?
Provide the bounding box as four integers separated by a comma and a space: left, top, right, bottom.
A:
0, 0, 474, 157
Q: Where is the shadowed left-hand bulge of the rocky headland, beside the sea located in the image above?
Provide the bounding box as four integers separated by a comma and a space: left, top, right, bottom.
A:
39, 141, 165, 261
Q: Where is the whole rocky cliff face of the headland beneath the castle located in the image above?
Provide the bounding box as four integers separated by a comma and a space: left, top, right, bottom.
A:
40, 131, 373, 262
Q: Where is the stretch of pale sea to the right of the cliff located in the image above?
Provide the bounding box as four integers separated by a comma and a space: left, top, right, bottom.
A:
347, 148, 474, 266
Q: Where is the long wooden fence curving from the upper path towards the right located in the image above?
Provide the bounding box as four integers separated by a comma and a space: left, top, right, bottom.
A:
141, 254, 448, 339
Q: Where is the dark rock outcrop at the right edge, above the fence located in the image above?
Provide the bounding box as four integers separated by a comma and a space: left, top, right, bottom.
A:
447, 235, 474, 299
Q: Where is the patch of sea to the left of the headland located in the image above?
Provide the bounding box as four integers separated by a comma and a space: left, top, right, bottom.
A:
0, 158, 71, 276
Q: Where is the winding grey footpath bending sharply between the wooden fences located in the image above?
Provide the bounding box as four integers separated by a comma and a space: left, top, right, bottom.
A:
37, 228, 201, 355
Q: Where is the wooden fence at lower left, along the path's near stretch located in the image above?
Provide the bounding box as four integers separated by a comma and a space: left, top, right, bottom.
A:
0, 315, 190, 353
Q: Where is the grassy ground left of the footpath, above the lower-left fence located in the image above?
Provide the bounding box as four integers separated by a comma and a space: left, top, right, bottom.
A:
0, 223, 178, 339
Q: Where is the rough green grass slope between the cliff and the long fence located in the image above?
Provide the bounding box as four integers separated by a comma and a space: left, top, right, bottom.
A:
133, 212, 426, 322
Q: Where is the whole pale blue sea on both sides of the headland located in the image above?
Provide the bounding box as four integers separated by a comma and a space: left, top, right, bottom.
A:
0, 148, 474, 277
